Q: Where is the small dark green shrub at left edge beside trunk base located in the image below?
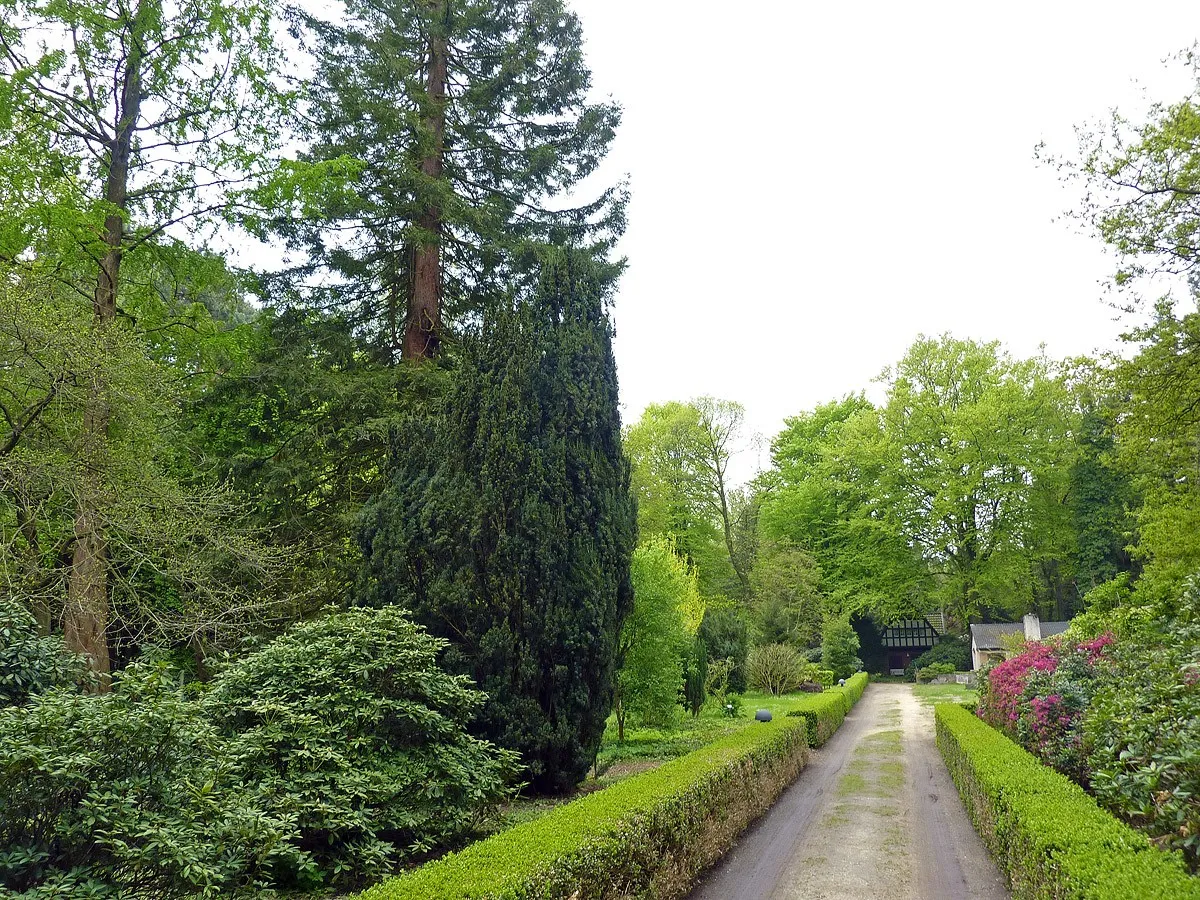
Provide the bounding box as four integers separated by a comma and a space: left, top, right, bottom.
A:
0, 595, 89, 706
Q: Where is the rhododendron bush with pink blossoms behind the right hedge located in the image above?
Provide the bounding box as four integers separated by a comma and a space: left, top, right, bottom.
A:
978, 586, 1200, 871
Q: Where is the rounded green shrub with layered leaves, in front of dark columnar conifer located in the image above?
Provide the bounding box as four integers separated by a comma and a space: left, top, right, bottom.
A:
205, 607, 516, 882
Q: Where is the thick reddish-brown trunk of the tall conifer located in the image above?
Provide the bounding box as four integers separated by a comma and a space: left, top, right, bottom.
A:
402, 6, 448, 362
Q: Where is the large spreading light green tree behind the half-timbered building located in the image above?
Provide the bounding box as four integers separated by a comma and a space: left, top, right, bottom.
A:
762, 336, 1073, 620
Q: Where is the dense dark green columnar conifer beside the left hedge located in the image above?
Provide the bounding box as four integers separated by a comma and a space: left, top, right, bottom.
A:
362, 251, 636, 792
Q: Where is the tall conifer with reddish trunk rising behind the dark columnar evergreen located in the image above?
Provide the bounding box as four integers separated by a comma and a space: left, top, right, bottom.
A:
284, 0, 625, 360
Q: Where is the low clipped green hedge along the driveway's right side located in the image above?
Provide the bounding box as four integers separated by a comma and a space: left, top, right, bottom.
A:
936, 703, 1200, 900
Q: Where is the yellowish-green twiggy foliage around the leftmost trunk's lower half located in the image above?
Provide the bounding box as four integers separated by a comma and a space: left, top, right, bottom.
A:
0, 280, 278, 642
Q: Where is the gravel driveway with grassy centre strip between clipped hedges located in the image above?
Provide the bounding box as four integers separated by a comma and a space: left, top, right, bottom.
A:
691, 684, 1009, 900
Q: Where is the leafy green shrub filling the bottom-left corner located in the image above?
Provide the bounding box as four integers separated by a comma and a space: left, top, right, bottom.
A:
0, 665, 304, 900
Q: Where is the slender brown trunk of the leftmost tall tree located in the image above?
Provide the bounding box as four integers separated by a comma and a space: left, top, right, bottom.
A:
62, 19, 142, 690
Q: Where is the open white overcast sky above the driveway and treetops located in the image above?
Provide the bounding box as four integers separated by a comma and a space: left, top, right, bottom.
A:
570, 0, 1200, 478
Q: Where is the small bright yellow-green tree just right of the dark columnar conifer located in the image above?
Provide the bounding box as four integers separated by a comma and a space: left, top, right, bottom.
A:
614, 538, 703, 732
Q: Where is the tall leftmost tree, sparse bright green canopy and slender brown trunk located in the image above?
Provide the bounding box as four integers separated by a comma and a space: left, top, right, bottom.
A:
0, 0, 297, 684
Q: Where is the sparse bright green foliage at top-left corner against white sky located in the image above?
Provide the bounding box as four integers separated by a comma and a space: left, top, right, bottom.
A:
0, 0, 295, 278
